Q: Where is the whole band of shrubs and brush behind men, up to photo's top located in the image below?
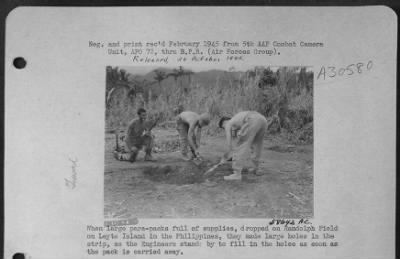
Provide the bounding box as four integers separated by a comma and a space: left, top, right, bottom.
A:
106, 67, 313, 143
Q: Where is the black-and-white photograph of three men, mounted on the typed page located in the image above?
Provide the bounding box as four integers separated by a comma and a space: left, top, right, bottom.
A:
104, 65, 314, 219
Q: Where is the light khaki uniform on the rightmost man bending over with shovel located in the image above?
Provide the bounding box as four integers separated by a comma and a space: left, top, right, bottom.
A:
225, 111, 268, 173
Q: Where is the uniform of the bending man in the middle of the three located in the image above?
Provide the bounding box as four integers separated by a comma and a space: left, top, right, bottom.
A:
176, 111, 201, 158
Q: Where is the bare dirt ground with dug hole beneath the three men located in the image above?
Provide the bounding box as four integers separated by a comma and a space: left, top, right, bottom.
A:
104, 128, 313, 219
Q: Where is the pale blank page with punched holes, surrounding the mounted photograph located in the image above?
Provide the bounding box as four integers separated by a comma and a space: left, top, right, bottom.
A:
4, 7, 397, 258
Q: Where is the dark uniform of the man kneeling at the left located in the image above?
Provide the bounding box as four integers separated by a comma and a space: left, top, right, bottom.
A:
118, 119, 155, 162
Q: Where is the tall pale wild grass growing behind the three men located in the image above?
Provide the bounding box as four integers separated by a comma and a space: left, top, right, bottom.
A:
106, 69, 313, 142
